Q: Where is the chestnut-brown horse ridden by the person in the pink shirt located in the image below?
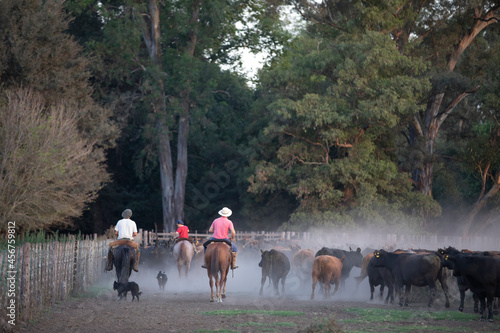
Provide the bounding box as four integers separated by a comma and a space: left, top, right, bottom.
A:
205, 242, 231, 303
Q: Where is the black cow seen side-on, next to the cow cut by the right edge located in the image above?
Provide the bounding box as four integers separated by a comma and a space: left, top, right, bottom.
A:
371, 250, 450, 308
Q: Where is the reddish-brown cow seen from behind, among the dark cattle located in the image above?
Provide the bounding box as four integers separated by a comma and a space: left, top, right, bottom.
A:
311, 255, 345, 299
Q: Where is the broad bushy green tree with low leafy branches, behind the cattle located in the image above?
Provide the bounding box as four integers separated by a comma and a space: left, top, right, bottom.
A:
249, 32, 438, 232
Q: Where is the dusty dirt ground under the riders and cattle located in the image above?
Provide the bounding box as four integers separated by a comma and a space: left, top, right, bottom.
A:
17, 252, 500, 332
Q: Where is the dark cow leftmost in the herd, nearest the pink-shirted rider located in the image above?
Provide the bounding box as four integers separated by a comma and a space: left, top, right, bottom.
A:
259, 249, 290, 296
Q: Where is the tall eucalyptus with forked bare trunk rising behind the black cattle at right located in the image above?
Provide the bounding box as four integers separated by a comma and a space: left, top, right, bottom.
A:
278, 0, 500, 233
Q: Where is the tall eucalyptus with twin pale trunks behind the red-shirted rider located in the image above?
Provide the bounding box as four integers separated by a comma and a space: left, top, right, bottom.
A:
79, 0, 286, 230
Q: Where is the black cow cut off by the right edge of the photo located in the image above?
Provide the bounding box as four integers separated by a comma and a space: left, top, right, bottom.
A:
443, 253, 500, 321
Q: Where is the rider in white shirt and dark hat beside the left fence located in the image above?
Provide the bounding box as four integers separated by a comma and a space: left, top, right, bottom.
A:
105, 208, 141, 272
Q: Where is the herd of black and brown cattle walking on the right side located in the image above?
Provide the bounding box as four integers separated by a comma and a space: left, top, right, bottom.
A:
259, 241, 500, 321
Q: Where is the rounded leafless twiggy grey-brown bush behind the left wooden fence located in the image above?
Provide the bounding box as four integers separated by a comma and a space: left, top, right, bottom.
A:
0, 89, 107, 232
